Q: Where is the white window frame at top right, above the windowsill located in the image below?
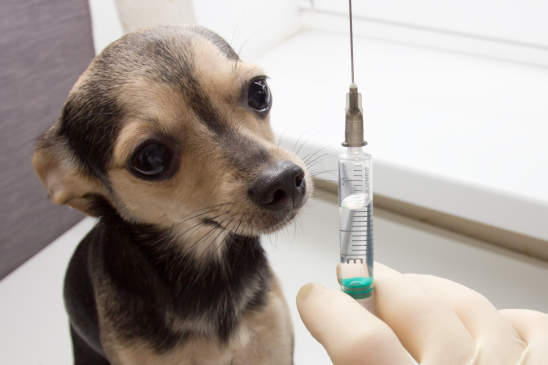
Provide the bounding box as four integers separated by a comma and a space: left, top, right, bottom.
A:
299, 0, 548, 67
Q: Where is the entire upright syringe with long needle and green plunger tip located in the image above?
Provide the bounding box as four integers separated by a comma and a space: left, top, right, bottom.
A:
339, 0, 373, 310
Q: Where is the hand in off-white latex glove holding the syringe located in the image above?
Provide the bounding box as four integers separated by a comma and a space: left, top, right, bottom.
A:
297, 263, 548, 365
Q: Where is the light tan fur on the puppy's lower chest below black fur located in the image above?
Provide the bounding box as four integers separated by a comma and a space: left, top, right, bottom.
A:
102, 280, 293, 365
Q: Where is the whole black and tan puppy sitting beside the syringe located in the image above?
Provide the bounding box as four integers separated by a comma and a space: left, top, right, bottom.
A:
33, 26, 312, 365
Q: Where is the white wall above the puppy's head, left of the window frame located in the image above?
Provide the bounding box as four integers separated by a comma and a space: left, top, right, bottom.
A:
89, 0, 299, 59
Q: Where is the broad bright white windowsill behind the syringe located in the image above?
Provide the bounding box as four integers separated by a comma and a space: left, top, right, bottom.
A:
256, 29, 548, 240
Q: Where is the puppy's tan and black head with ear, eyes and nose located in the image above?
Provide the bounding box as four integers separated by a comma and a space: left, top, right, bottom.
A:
33, 27, 312, 250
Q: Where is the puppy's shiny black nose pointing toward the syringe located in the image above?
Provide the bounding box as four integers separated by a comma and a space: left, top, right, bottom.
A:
247, 161, 306, 210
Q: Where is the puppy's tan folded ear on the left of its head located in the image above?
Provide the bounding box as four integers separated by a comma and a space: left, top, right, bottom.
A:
32, 124, 104, 216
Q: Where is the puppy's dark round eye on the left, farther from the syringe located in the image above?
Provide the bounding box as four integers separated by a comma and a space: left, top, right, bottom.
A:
130, 141, 173, 179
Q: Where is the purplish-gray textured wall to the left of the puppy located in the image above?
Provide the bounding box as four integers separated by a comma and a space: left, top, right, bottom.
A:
0, 0, 94, 278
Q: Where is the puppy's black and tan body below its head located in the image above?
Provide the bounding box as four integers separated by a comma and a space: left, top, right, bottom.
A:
65, 212, 293, 365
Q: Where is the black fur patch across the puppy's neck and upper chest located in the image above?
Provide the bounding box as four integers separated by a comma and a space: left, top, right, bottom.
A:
78, 210, 272, 352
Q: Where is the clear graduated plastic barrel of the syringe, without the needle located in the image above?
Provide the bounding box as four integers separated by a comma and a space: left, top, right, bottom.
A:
339, 147, 373, 276
